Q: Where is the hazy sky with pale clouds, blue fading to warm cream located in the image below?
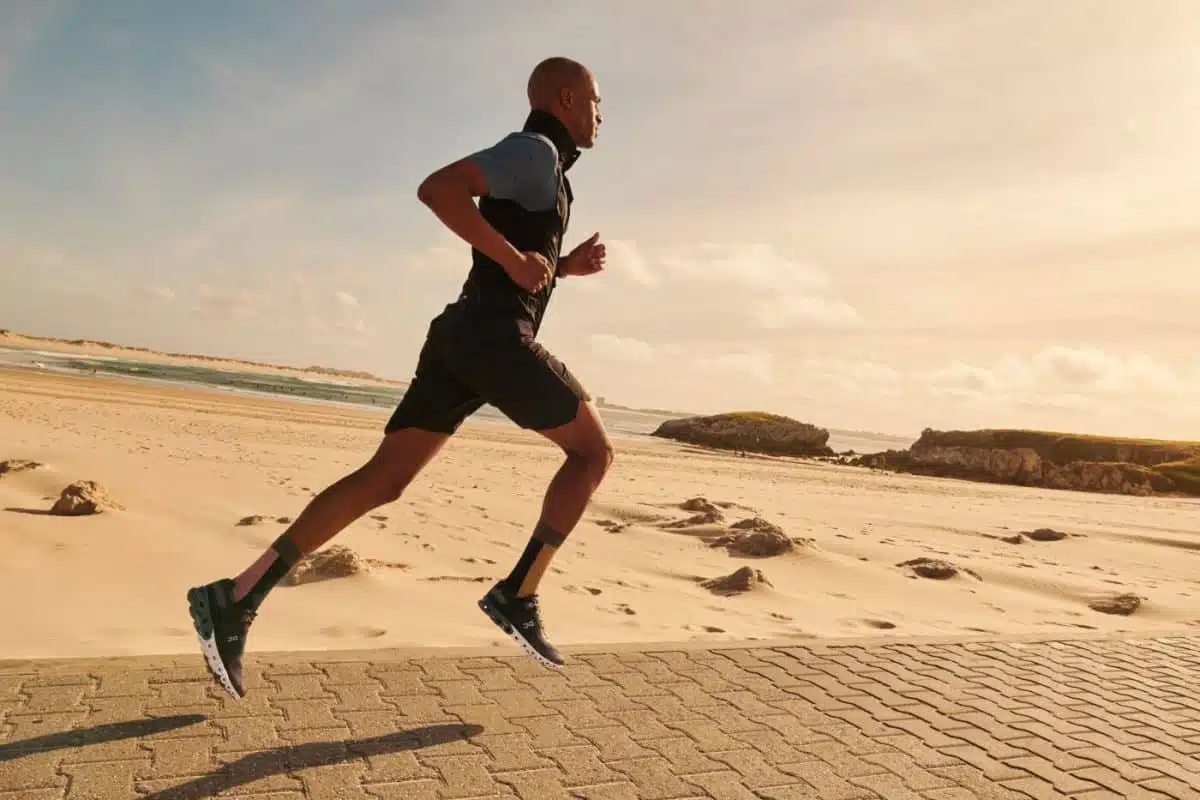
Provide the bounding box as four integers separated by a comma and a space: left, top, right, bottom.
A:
0, 0, 1200, 439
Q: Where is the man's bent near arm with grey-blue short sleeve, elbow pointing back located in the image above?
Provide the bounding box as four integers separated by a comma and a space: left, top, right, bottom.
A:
416, 137, 558, 273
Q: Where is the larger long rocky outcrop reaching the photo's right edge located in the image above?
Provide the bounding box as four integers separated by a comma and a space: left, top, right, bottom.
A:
850, 428, 1200, 495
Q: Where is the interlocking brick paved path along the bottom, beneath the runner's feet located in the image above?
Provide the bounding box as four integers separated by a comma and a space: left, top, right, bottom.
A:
0, 636, 1200, 800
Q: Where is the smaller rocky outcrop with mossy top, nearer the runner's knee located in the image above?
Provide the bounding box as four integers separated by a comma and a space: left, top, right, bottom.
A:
650, 411, 834, 457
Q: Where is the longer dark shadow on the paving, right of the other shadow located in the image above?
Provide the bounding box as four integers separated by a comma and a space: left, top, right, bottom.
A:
142, 723, 484, 800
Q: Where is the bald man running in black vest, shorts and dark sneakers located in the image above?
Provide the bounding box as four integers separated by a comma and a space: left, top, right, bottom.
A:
187, 58, 613, 698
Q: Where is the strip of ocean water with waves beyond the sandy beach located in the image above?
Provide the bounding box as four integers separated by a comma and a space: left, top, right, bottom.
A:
0, 347, 913, 453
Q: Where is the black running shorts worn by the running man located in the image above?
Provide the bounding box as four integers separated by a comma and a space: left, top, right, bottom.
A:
385, 317, 590, 434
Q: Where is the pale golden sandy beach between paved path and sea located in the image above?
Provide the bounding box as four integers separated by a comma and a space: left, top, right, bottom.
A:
0, 369, 1200, 658
